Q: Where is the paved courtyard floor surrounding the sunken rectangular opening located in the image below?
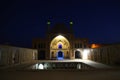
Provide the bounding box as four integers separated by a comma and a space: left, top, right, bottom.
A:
0, 59, 120, 80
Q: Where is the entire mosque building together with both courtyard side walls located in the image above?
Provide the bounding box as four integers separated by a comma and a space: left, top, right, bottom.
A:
0, 24, 120, 65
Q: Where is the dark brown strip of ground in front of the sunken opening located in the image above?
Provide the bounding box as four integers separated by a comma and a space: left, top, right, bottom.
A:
0, 69, 120, 80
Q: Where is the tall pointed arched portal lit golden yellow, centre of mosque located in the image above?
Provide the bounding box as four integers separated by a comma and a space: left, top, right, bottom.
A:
50, 35, 70, 59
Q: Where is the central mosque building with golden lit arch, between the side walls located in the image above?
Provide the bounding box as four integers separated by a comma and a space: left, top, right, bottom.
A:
33, 24, 88, 60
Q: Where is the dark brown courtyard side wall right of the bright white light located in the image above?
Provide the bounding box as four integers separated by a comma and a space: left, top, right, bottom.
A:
90, 44, 120, 65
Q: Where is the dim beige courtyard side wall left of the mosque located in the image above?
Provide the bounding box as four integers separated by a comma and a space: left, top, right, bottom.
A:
0, 45, 37, 65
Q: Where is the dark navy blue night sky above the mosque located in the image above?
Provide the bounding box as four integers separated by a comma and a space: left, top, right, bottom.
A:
0, 0, 120, 47
